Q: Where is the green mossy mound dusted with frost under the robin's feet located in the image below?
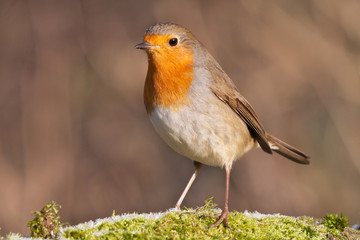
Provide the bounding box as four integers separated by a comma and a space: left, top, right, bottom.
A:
3, 202, 360, 239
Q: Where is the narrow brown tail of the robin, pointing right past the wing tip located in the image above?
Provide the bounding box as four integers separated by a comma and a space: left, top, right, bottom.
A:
266, 134, 310, 164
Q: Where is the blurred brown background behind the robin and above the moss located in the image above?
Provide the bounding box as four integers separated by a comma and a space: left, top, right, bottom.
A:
0, 0, 360, 236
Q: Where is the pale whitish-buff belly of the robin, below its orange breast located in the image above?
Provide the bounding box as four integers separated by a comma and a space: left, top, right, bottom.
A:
150, 91, 257, 167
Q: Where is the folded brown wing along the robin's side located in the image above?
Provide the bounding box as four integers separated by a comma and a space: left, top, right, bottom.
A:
210, 66, 272, 153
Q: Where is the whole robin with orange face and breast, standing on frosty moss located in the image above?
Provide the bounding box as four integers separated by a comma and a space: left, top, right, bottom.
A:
135, 22, 310, 228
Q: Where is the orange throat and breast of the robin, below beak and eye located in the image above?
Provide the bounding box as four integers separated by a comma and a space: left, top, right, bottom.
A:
144, 37, 193, 113
